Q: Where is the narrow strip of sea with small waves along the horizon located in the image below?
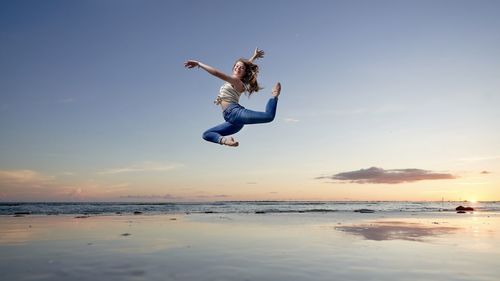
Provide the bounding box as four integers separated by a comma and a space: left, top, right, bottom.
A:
0, 201, 500, 215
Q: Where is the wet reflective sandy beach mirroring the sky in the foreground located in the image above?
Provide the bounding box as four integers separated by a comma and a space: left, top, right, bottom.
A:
0, 212, 500, 280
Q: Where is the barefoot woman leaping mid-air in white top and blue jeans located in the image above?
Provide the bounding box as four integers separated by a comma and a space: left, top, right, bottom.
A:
184, 48, 281, 146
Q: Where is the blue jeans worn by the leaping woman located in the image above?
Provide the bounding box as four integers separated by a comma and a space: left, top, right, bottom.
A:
203, 98, 278, 144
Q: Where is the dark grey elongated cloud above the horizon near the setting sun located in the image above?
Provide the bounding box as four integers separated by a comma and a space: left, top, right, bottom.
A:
316, 167, 457, 184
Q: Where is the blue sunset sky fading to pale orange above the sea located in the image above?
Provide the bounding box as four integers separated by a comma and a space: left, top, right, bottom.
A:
0, 0, 500, 202
